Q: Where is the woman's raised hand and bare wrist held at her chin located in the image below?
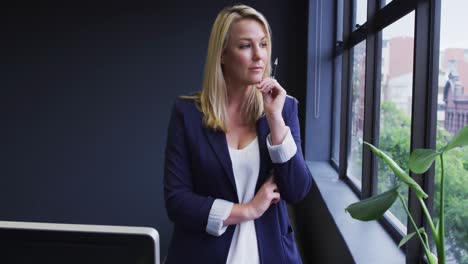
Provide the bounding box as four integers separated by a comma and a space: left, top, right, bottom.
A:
256, 77, 288, 145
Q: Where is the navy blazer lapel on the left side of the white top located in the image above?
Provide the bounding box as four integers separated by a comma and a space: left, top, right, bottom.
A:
204, 128, 237, 193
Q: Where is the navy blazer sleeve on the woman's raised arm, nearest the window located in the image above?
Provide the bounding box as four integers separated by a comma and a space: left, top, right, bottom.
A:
273, 100, 312, 203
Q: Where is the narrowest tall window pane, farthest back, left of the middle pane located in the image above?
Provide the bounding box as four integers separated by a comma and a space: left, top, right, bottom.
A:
347, 41, 366, 189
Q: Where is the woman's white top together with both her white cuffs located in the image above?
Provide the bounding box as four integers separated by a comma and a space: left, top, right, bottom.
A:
206, 129, 297, 264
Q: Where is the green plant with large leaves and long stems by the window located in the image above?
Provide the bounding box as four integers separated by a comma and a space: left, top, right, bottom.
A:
346, 126, 468, 264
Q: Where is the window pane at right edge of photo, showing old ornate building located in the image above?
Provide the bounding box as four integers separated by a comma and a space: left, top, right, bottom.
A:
434, 0, 468, 263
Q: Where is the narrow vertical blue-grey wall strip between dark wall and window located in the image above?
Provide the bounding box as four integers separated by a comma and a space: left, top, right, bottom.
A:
305, 0, 336, 161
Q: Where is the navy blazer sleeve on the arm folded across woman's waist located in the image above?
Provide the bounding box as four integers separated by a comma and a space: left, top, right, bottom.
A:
164, 102, 215, 232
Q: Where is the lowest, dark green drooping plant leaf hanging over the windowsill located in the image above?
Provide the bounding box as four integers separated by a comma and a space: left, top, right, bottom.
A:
345, 185, 400, 221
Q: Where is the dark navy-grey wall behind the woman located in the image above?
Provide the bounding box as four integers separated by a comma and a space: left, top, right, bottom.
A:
0, 0, 308, 256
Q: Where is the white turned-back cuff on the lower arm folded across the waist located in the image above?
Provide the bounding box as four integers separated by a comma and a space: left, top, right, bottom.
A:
206, 199, 234, 236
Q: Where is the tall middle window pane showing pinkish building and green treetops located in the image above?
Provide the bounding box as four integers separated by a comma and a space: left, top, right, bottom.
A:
378, 12, 414, 233
